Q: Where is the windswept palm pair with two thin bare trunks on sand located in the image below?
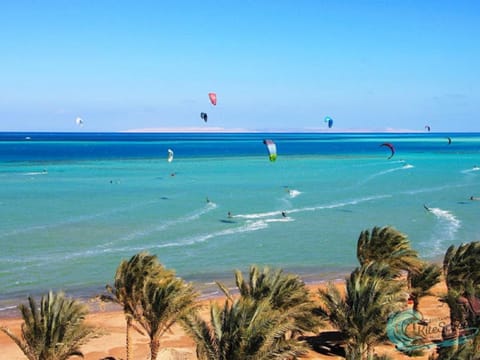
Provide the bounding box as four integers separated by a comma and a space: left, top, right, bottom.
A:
101, 252, 198, 360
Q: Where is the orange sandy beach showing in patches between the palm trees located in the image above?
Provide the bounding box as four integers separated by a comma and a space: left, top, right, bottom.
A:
0, 284, 449, 360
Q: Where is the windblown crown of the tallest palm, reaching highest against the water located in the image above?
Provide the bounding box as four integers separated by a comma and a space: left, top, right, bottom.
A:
357, 226, 422, 275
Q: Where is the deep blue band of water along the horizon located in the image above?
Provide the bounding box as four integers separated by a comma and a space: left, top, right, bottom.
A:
0, 133, 479, 161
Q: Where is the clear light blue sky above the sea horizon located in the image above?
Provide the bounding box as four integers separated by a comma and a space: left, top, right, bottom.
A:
0, 0, 480, 132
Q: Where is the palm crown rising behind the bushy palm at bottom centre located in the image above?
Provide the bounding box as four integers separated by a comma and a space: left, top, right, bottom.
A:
217, 265, 320, 335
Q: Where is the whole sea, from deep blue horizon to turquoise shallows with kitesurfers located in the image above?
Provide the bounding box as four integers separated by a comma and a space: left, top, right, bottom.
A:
0, 132, 480, 317
